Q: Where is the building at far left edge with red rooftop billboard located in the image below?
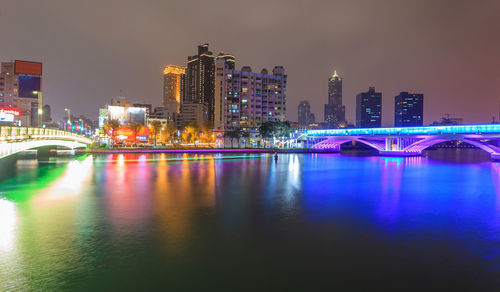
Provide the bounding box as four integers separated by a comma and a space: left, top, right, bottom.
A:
0, 60, 43, 126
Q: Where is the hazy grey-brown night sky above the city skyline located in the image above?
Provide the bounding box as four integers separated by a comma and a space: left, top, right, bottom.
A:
0, 0, 500, 126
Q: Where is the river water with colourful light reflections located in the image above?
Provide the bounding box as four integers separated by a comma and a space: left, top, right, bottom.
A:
0, 149, 500, 291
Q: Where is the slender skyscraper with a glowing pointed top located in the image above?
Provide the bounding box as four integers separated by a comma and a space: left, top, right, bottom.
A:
325, 71, 345, 128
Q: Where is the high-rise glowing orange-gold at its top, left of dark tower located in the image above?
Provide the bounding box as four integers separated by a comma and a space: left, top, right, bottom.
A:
163, 65, 186, 113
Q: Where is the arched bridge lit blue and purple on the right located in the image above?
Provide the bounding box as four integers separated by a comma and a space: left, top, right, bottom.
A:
304, 124, 500, 160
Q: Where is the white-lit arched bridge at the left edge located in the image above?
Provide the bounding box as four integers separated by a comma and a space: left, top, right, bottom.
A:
0, 127, 92, 159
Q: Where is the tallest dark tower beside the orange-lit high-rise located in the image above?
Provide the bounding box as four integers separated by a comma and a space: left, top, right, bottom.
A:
181, 44, 215, 125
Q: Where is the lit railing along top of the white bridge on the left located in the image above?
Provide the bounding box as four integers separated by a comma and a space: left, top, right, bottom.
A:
0, 126, 92, 144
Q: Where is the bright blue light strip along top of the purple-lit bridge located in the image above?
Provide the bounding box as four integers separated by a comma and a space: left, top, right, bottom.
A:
306, 124, 500, 136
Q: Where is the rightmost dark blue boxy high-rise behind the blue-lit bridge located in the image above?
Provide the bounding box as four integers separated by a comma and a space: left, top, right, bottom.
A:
394, 92, 424, 127
